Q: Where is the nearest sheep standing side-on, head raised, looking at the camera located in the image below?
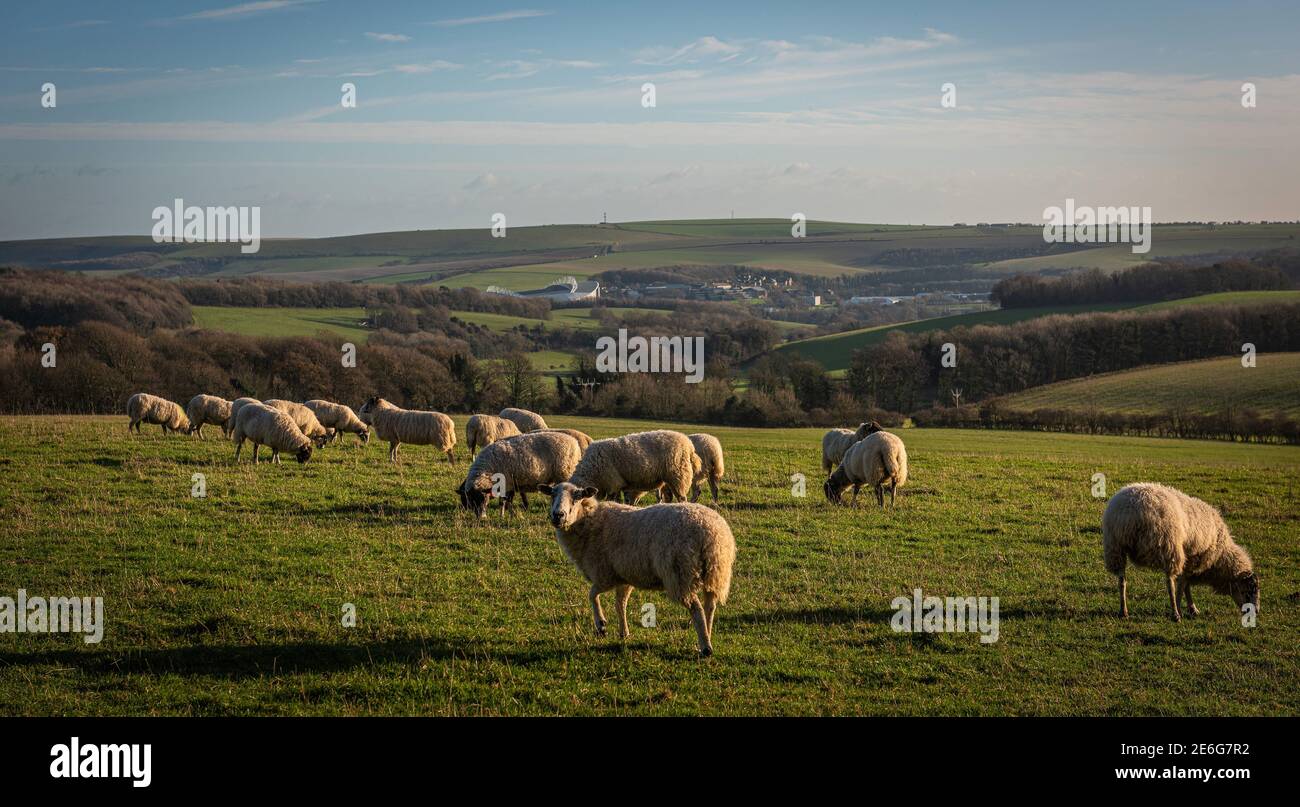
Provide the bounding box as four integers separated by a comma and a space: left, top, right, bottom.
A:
540, 480, 736, 656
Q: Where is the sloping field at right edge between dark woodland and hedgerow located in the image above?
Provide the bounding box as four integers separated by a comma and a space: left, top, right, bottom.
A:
998, 353, 1300, 417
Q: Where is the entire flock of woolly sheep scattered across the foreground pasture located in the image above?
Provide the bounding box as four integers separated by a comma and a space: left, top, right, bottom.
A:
126, 392, 1260, 656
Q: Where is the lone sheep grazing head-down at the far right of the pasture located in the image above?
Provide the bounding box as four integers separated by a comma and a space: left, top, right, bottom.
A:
1101, 482, 1260, 622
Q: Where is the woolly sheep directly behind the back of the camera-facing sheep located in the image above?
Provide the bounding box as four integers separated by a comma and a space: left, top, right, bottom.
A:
569, 429, 702, 502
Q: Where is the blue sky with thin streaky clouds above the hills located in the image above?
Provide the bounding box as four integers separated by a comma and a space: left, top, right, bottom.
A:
0, 0, 1300, 240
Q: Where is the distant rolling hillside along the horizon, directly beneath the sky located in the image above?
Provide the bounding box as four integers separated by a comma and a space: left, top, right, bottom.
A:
0, 218, 1300, 290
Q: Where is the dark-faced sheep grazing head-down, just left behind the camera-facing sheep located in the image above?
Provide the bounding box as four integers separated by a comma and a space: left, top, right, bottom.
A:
456, 421, 582, 519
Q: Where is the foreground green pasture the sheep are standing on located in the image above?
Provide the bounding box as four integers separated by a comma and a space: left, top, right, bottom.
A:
0, 416, 1300, 715
